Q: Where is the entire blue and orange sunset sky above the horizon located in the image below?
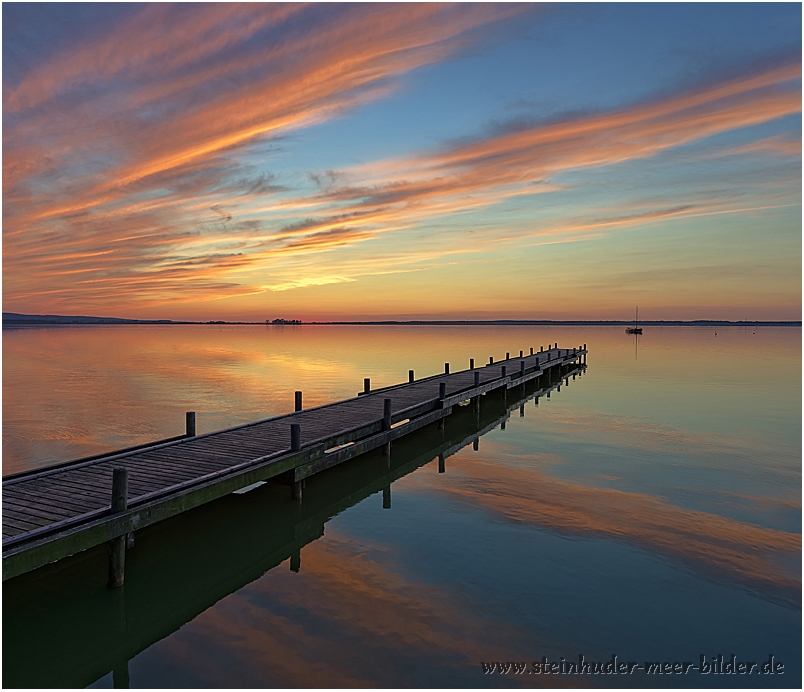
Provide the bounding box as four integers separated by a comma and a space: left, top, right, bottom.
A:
2, 3, 802, 321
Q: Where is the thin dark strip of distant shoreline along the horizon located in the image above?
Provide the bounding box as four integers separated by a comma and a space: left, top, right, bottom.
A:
3, 312, 801, 327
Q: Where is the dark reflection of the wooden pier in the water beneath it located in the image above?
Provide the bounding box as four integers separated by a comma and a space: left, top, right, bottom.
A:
3, 366, 586, 688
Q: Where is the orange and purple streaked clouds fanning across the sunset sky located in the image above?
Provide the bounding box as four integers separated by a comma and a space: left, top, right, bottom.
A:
3, 3, 801, 317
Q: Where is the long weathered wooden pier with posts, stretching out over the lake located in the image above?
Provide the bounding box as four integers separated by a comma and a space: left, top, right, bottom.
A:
3, 344, 587, 586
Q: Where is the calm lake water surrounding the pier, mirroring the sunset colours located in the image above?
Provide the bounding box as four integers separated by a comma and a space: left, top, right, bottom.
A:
3, 326, 801, 687
